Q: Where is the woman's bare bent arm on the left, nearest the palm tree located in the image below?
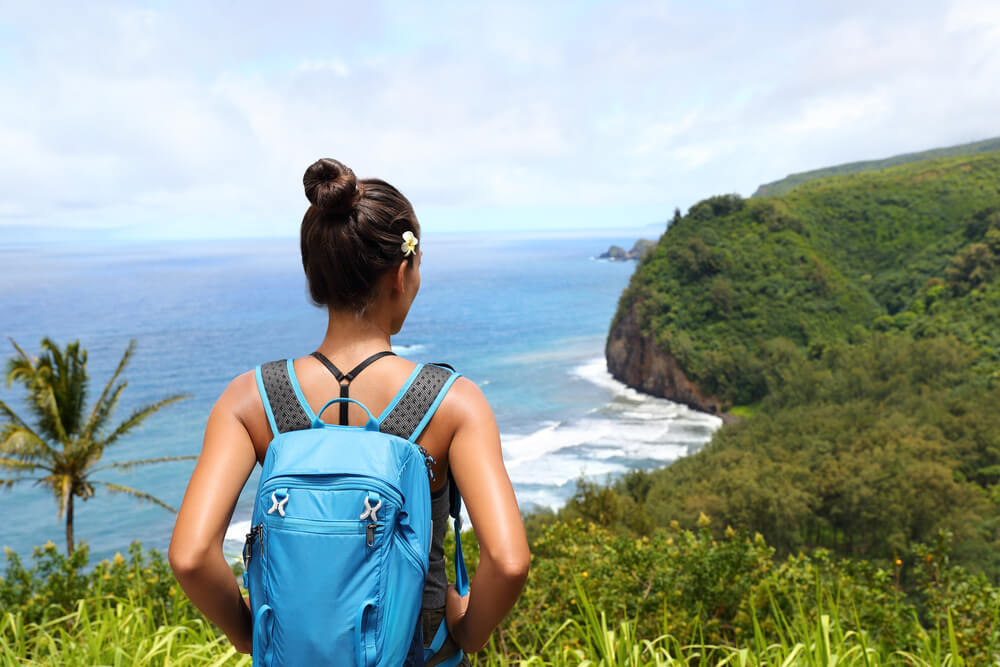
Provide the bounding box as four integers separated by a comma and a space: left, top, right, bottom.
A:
169, 373, 260, 653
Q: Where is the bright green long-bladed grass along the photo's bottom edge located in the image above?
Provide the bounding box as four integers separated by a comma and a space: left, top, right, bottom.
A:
0, 589, 965, 667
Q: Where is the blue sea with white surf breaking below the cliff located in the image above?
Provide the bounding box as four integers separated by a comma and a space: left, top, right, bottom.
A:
0, 232, 720, 559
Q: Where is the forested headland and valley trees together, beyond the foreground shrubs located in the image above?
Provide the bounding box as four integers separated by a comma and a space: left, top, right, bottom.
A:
604, 147, 1000, 580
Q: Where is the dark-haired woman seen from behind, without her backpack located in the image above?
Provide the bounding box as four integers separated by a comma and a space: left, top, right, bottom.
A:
169, 159, 529, 665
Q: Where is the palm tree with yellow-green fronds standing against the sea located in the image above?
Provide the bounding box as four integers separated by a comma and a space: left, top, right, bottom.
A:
0, 337, 197, 554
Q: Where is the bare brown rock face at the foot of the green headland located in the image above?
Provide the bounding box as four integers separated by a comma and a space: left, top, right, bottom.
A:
604, 306, 738, 423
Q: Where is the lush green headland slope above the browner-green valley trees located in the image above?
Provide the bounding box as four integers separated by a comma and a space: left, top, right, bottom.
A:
612, 152, 1000, 405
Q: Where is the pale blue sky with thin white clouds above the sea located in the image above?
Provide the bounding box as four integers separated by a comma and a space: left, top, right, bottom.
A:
0, 0, 1000, 242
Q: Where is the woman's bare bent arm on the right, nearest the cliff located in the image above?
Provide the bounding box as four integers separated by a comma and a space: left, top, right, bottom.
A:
446, 379, 530, 652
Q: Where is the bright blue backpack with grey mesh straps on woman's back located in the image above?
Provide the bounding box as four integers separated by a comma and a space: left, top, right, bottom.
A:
243, 354, 468, 667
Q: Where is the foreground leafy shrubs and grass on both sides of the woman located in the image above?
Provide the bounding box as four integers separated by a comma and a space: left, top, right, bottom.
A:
0, 536, 1000, 667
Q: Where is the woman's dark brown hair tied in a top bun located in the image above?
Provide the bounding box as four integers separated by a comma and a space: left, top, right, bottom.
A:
301, 158, 420, 313
